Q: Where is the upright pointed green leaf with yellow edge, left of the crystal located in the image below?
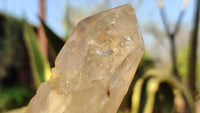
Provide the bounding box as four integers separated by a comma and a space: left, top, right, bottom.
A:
23, 22, 51, 87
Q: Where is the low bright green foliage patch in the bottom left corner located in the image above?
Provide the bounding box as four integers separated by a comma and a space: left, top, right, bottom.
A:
0, 86, 33, 112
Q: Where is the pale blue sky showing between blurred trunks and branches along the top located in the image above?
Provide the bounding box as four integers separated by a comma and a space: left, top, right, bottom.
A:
0, 0, 194, 36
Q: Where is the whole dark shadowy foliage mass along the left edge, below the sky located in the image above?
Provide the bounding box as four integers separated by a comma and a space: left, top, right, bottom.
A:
0, 13, 33, 113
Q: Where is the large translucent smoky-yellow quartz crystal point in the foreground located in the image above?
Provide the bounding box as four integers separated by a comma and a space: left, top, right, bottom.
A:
26, 4, 144, 113
